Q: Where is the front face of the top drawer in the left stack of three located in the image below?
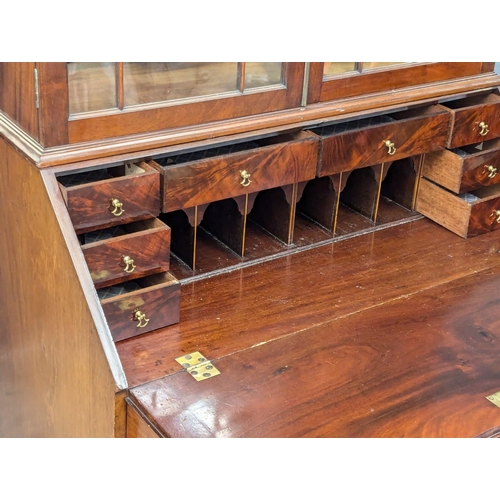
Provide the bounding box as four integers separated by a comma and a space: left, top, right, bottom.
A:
64, 166, 160, 233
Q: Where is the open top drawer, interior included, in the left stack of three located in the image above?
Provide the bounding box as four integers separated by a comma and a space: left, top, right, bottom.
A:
57, 162, 160, 234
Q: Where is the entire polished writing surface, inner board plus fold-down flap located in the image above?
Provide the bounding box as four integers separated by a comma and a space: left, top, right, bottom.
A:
127, 220, 500, 437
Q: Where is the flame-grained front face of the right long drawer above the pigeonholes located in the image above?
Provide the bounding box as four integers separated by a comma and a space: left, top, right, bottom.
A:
318, 111, 451, 177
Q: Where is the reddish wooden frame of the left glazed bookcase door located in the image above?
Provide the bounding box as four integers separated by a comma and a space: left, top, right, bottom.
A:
37, 63, 305, 147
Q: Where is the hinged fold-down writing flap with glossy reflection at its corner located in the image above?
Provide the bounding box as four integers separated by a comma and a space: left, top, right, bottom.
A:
131, 266, 500, 438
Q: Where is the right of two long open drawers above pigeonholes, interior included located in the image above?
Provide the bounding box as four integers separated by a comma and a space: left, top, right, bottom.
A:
311, 106, 451, 177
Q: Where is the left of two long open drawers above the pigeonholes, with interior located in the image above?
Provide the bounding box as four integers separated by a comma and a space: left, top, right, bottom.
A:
150, 132, 318, 212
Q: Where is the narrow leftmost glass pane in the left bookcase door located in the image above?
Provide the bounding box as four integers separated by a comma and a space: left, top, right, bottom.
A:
68, 62, 116, 115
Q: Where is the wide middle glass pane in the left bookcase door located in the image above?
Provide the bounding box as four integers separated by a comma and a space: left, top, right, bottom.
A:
123, 62, 238, 106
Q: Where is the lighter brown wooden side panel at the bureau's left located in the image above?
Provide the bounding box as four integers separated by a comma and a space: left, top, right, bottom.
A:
0, 139, 117, 437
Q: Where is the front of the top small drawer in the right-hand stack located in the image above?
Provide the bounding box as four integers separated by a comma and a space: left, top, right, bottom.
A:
448, 96, 500, 148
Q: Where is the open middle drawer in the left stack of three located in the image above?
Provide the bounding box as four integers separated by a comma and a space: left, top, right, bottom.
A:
80, 219, 170, 288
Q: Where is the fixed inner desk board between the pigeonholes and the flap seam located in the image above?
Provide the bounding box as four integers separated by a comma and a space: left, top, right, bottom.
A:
117, 219, 500, 387
